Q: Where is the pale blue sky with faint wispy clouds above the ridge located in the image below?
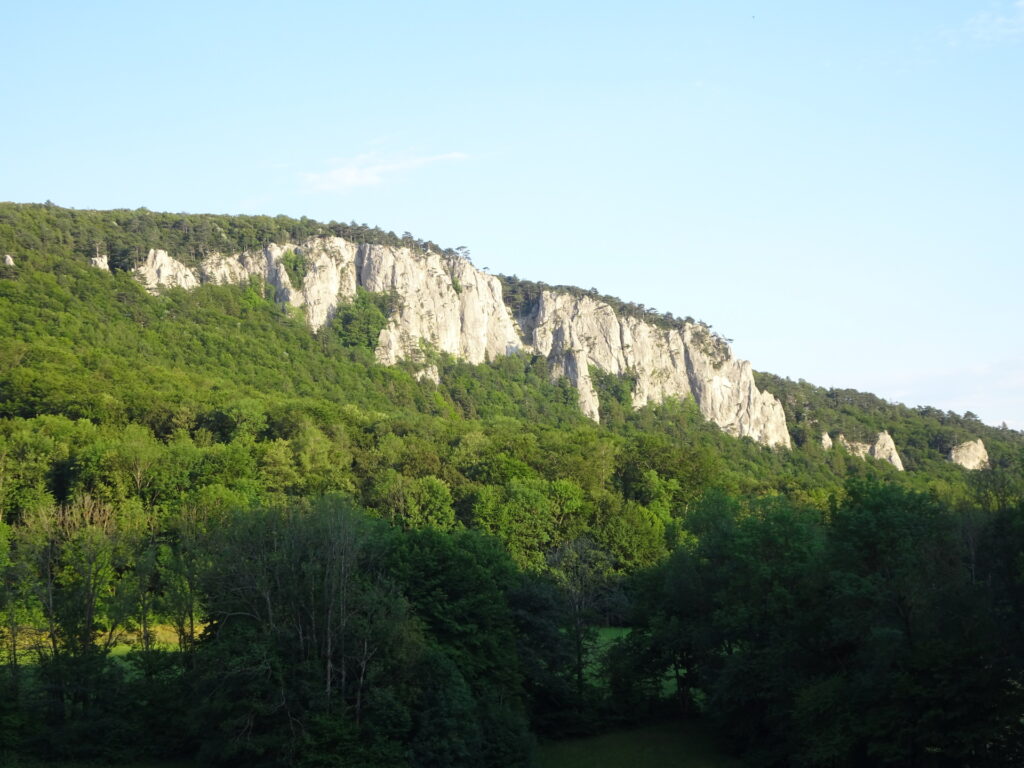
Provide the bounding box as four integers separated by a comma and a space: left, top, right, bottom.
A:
6, 0, 1024, 429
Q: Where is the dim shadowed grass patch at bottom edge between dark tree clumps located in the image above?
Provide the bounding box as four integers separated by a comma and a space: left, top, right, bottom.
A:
539, 723, 742, 768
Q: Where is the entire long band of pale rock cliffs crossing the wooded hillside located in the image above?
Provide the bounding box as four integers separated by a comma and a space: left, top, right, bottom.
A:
136, 238, 790, 448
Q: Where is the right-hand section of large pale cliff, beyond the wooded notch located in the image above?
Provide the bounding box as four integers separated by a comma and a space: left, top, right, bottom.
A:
523, 291, 790, 447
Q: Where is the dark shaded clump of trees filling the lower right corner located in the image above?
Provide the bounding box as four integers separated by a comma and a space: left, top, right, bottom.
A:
616, 482, 1024, 766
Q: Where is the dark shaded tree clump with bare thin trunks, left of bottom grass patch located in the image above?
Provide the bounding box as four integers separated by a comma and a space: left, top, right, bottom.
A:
189, 499, 527, 766
